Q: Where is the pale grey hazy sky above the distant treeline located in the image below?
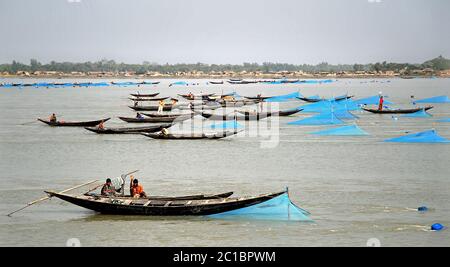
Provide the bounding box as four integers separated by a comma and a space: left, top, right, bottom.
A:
0, 0, 450, 64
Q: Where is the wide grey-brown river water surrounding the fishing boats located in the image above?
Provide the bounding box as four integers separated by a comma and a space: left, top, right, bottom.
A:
0, 79, 450, 247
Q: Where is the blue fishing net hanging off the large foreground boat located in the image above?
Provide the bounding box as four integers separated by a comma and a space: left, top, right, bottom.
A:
208, 193, 312, 221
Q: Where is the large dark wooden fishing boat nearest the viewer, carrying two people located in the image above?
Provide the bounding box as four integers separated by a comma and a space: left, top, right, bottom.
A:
46, 191, 286, 216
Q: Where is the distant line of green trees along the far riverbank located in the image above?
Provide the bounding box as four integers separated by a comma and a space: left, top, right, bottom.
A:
0, 56, 450, 74
